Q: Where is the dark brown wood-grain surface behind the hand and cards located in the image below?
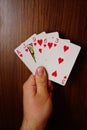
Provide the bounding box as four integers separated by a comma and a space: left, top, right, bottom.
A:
0, 0, 87, 130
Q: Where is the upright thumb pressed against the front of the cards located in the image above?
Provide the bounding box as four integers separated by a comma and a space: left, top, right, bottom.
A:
35, 67, 48, 95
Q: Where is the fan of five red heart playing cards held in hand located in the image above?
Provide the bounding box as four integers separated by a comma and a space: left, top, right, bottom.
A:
14, 32, 81, 86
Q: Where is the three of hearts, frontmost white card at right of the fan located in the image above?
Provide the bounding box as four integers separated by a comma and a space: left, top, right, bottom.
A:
39, 39, 81, 86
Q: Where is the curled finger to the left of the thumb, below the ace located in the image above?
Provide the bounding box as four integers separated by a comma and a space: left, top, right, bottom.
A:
23, 74, 36, 96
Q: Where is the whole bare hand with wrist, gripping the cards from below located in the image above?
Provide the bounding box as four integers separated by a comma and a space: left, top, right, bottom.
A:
21, 67, 53, 130
